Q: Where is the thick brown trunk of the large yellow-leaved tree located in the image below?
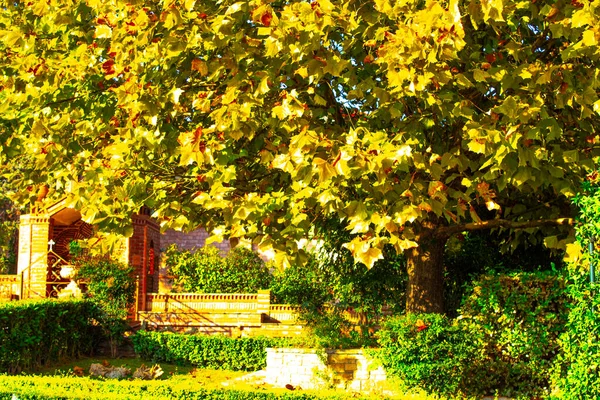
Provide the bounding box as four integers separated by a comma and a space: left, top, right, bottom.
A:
406, 237, 447, 314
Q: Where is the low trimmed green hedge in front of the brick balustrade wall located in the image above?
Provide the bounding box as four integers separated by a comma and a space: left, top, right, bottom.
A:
132, 331, 288, 371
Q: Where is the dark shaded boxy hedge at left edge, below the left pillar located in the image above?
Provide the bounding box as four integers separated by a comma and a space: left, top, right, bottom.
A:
0, 300, 98, 373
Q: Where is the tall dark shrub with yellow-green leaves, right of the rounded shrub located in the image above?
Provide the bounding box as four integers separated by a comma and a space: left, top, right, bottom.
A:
461, 272, 568, 397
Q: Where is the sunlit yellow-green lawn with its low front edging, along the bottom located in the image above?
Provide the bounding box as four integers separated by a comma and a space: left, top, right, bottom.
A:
0, 358, 436, 400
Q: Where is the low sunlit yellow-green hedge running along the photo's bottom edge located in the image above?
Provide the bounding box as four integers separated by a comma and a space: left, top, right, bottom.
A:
0, 376, 364, 400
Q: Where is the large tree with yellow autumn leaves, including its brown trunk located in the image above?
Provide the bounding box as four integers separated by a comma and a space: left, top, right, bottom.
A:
0, 0, 600, 312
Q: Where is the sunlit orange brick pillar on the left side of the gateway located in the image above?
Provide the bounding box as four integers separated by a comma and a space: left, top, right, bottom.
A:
17, 214, 50, 298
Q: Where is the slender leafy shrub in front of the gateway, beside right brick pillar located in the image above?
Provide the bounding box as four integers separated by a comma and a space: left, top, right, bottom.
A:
73, 256, 135, 356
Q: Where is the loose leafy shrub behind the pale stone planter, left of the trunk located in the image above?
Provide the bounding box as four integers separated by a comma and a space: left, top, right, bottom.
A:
271, 238, 407, 348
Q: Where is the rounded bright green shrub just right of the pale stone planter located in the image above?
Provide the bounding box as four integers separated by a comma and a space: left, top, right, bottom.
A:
377, 314, 486, 396
